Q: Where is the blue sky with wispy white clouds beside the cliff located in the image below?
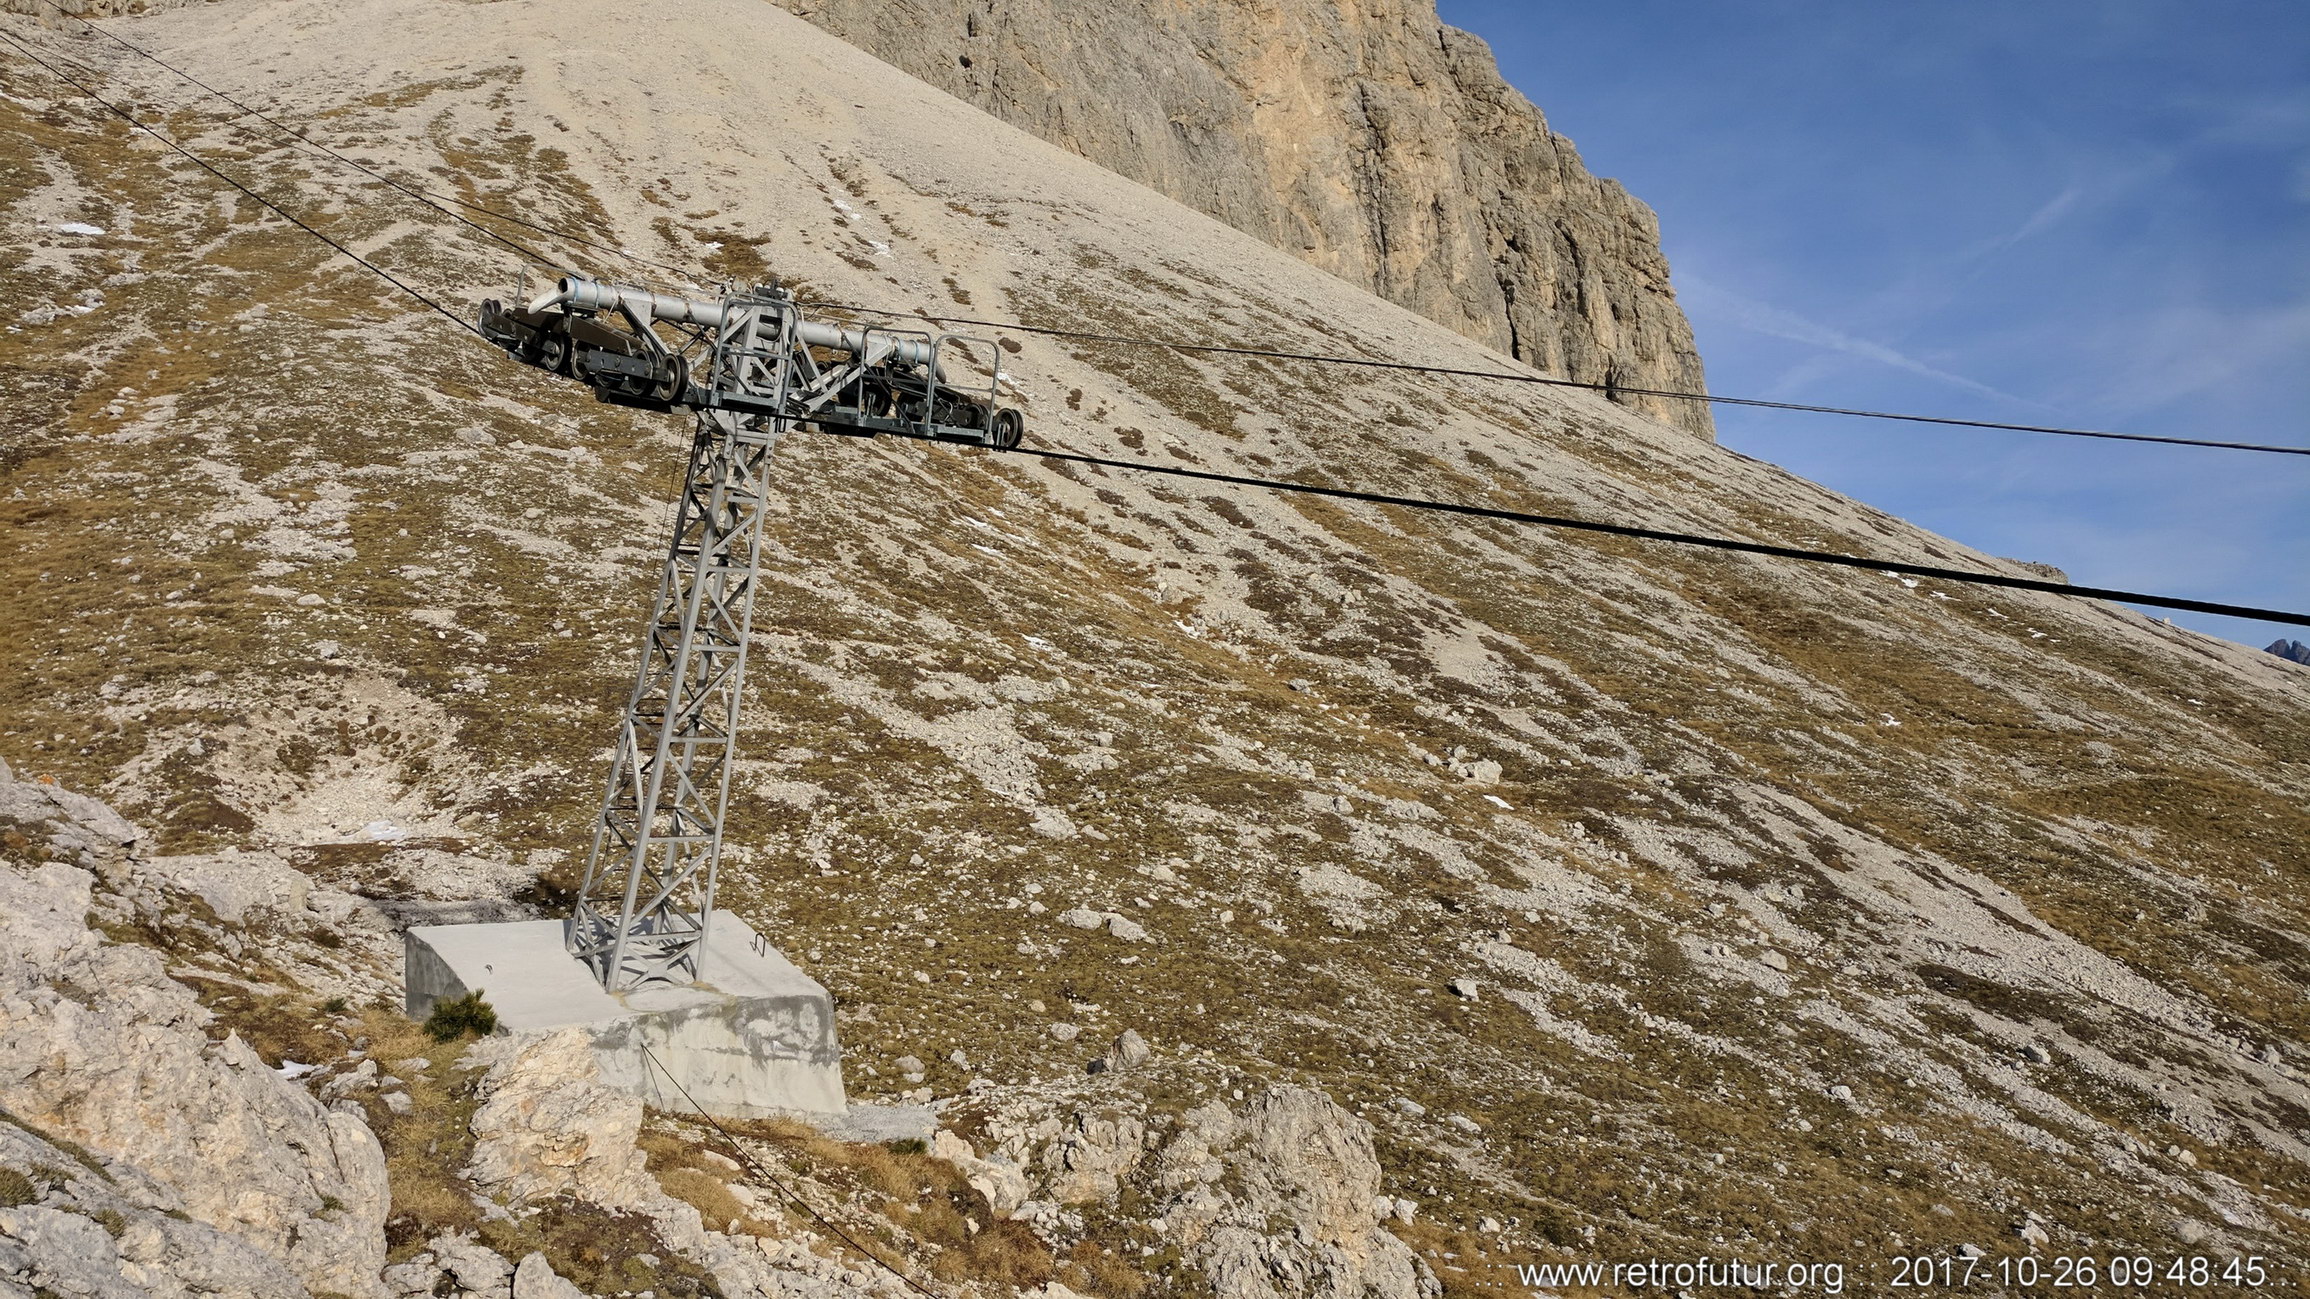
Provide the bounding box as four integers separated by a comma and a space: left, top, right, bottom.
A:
1439, 0, 2310, 647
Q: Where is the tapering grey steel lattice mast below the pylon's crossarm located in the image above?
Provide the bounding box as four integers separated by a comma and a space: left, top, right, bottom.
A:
566, 409, 783, 992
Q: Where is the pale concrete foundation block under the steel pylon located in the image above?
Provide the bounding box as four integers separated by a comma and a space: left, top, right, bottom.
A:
407, 911, 850, 1119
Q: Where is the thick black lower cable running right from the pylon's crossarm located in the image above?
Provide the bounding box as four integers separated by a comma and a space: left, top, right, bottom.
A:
1009, 446, 2310, 626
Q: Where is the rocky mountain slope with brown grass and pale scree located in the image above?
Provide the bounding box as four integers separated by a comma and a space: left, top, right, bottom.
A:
0, 0, 2310, 1299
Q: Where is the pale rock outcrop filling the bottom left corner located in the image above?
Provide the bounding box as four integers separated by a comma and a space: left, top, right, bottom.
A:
0, 767, 388, 1294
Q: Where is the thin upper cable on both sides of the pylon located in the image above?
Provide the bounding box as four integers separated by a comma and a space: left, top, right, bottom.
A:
45, 9, 2310, 455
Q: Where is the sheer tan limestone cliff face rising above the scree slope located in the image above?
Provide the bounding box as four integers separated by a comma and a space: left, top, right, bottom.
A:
781, 0, 1714, 435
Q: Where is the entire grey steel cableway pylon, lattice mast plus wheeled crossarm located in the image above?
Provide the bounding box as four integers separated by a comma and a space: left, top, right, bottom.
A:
474, 275, 1026, 992
